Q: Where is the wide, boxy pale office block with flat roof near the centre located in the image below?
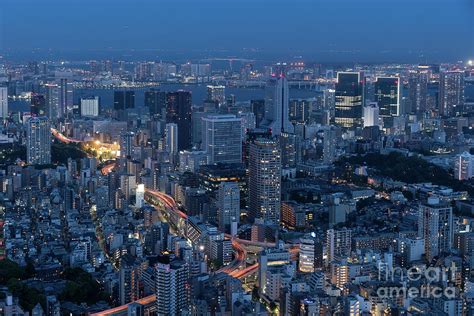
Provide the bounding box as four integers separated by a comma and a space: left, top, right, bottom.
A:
201, 114, 242, 164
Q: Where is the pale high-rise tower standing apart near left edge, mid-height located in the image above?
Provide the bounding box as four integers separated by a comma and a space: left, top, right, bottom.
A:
26, 116, 51, 165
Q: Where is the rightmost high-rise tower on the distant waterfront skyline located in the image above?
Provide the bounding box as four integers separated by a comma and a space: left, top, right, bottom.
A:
438, 71, 464, 116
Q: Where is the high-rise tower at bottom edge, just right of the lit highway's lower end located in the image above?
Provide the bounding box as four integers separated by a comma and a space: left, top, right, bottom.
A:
155, 255, 189, 315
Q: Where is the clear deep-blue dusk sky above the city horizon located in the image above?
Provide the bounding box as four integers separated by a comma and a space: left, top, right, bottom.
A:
0, 0, 474, 60
